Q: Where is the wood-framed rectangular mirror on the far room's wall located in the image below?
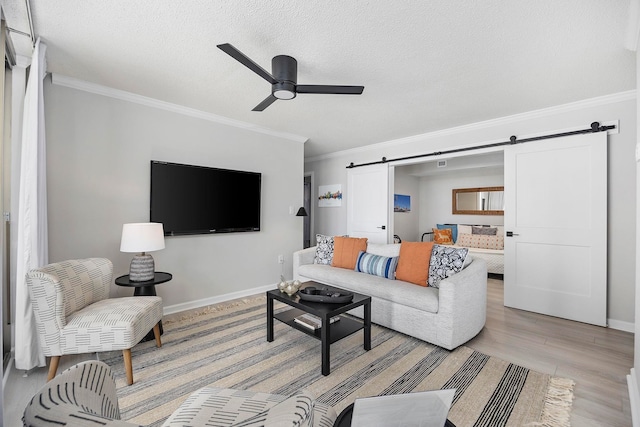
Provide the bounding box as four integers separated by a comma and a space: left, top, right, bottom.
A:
452, 187, 504, 215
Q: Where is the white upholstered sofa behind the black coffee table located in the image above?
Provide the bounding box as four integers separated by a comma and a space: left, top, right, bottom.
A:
293, 244, 487, 350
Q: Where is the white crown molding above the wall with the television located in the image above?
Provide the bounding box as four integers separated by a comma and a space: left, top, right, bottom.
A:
51, 73, 309, 144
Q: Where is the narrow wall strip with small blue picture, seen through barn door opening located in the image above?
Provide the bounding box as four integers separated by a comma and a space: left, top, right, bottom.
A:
393, 168, 422, 242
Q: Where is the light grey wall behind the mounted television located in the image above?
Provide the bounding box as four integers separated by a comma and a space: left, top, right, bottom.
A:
44, 79, 304, 310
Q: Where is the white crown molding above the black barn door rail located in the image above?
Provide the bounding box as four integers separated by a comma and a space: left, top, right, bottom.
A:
304, 89, 636, 163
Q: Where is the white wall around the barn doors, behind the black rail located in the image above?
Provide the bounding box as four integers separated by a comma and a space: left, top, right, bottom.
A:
305, 91, 637, 330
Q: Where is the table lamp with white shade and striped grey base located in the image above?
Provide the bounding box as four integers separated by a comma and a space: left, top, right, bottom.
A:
120, 222, 164, 282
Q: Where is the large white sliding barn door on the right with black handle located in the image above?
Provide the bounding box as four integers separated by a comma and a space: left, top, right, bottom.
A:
504, 132, 607, 326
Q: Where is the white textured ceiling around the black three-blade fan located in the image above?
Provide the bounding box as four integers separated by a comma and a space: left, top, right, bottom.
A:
2, 0, 636, 157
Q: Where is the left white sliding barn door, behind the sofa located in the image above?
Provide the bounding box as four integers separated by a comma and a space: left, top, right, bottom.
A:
347, 163, 393, 243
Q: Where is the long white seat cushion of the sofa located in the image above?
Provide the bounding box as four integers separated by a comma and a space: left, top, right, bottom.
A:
298, 264, 438, 313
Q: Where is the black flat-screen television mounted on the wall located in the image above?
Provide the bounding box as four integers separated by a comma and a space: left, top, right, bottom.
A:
150, 160, 262, 236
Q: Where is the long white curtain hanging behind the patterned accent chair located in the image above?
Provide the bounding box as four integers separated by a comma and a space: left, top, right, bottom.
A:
15, 39, 49, 370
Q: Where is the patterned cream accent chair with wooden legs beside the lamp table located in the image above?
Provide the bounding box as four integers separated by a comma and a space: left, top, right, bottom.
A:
26, 258, 162, 385
